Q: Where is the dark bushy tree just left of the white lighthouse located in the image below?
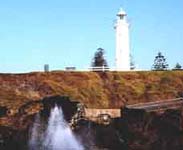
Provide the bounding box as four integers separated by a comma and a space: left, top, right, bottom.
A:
92, 48, 108, 67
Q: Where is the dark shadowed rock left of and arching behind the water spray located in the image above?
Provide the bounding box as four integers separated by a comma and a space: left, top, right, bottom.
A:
0, 96, 77, 150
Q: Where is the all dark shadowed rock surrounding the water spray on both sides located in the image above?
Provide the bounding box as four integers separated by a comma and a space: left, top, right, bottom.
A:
0, 99, 183, 150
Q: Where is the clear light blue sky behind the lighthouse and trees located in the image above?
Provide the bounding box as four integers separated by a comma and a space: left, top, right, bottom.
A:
0, 0, 183, 72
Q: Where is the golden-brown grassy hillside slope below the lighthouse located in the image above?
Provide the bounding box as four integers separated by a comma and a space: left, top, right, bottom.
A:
0, 71, 183, 109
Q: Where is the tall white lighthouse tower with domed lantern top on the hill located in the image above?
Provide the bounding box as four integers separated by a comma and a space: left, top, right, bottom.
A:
115, 9, 130, 71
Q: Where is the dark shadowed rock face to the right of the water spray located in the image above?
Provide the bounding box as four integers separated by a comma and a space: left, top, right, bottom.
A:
76, 109, 183, 150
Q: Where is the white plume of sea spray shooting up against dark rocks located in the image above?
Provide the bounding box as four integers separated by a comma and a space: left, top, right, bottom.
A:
29, 106, 84, 150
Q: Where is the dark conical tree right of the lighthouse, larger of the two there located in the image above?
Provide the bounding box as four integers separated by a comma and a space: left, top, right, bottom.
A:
152, 52, 168, 71
